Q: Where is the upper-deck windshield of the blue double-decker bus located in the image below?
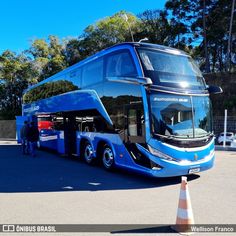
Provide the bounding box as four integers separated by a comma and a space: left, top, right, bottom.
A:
138, 49, 206, 90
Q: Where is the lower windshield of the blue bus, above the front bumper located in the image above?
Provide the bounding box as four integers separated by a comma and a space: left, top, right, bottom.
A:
150, 92, 212, 139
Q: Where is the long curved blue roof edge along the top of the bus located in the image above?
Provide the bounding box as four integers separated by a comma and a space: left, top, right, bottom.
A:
24, 42, 188, 93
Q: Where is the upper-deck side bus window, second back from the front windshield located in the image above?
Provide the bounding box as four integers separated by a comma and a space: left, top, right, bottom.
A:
82, 59, 103, 87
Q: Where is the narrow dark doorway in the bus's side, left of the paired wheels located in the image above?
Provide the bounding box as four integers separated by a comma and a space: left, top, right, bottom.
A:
63, 113, 77, 156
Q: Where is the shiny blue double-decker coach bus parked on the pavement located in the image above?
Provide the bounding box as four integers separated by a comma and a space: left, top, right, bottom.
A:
18, 43, 221, 177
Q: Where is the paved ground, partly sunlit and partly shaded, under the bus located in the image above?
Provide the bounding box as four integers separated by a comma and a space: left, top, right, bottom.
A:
0, 143, 236, 235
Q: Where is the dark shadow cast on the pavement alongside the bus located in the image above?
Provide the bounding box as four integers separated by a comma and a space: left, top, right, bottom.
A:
0, 145, 200, 193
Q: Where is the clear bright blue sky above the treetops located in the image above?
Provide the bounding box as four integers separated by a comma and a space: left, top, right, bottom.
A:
0, 0, 166, 53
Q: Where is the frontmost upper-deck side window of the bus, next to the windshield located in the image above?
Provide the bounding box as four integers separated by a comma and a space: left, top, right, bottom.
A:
105, 51, 137, 77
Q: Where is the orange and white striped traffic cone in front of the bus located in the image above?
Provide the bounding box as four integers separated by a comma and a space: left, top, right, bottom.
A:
172, 176, 194, 234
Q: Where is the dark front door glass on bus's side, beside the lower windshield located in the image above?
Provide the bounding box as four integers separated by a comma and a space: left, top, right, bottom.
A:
125, 103, 145, 143
